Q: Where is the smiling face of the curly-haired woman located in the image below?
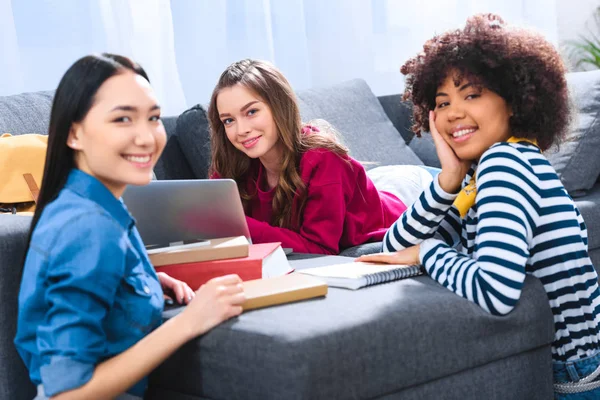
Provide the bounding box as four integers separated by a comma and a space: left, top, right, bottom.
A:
434, 71, 512, 160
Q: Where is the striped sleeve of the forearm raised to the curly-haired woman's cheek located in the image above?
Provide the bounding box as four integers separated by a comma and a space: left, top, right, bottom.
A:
383, 173, 461, 252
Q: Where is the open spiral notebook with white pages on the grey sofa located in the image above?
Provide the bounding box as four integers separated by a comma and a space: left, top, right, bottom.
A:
297, 262, 424, 290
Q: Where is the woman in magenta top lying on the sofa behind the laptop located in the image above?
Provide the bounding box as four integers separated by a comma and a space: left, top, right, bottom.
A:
208, 60, 424, 254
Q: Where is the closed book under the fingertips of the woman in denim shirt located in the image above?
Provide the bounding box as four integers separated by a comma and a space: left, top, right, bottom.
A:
242, 273, 327, 311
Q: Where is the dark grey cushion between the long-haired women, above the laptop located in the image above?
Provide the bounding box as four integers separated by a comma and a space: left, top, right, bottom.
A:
177, 104, 211, 179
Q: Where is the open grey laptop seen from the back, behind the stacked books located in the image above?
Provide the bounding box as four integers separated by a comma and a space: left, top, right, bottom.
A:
123, 179, 250, 248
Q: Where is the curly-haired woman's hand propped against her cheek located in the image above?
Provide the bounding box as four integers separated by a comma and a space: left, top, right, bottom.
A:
429, 111, 472, 193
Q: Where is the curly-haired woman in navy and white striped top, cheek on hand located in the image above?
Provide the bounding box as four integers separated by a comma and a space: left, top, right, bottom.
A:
360, 14, 600, 399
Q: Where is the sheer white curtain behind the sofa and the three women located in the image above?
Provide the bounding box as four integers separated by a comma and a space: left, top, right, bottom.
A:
0, 0, 557, 115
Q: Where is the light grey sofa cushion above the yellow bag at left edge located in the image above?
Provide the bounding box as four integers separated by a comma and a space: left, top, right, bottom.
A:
0, 91, 54, 135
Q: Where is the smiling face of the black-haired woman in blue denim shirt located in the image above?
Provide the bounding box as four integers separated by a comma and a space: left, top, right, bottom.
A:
67, 71, 166, 197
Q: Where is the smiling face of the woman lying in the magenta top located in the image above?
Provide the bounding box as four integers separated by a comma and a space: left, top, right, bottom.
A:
217, 83, 282, 164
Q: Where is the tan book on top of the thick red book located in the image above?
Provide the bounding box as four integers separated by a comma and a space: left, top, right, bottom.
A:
148, 236, 250, 267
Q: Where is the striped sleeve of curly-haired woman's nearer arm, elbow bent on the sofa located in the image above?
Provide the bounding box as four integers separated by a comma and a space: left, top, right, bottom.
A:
420, 145, 538, 315
